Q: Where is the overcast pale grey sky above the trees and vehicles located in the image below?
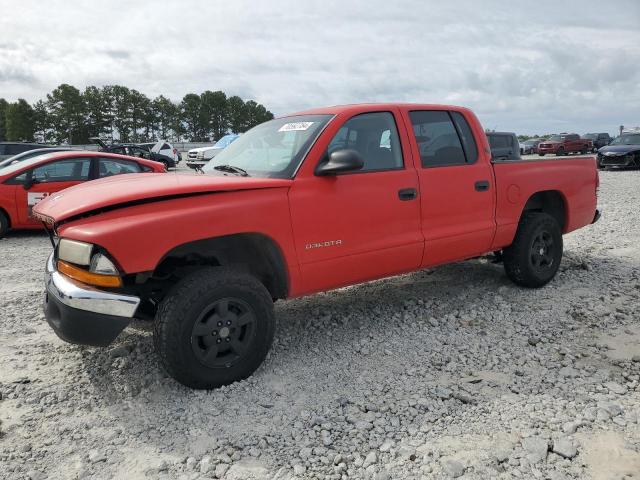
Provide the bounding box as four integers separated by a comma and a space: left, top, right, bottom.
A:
0, 0, 640, 134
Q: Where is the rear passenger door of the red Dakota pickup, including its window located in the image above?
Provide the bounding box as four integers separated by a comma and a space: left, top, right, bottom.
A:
406, 110, 495, 266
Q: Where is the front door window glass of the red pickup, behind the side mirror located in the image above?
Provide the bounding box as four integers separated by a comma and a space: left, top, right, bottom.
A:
328, 112, 403, 171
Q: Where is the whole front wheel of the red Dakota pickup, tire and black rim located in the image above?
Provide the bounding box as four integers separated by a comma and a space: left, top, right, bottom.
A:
154, 267, 275, 389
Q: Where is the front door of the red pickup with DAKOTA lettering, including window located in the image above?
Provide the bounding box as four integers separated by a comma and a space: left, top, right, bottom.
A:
289, 111, 424, 293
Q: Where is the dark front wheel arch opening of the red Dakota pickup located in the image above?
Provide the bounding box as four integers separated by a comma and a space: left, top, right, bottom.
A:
153, 232, 289, 299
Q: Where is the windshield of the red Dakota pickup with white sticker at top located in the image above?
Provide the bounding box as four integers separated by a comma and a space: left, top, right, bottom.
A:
203, 115, 333, 178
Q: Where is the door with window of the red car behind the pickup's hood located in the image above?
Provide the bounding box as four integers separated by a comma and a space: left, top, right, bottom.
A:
15, 157, 92, 225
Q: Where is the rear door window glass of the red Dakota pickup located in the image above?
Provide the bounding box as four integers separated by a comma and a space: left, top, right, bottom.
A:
409, 110, 466, 167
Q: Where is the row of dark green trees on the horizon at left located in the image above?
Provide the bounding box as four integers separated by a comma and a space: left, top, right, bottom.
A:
0, 84, 273, 144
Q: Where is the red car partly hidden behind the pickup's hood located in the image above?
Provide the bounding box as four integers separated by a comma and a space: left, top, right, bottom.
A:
0, 151, 166, 238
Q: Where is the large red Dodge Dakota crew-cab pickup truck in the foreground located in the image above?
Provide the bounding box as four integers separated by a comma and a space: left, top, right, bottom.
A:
35, 104, 599, 388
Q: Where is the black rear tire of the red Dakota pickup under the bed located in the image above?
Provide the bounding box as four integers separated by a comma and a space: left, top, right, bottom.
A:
503, 212, 563, 288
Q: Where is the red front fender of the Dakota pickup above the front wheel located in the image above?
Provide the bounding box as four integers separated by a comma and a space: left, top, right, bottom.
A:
58, 188, 298, 280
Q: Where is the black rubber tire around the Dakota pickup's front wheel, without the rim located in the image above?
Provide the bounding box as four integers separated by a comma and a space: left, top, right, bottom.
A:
153, 267, 275, 389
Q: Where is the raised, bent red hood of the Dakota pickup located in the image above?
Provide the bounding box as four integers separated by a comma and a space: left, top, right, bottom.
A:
34, 173, 292, 224
